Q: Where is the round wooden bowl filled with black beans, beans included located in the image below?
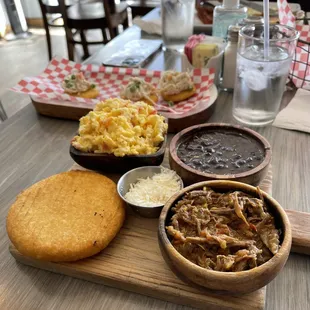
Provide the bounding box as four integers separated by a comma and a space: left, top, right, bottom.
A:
169, 123, 271, 185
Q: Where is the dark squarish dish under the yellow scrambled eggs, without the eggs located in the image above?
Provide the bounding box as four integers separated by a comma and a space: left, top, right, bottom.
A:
70, 136, 167, 172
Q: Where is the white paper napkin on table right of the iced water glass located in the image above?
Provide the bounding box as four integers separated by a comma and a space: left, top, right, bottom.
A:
272, 88, 310, 133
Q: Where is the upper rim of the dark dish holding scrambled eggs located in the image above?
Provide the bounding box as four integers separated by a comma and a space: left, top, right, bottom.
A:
70, 134, 167, 160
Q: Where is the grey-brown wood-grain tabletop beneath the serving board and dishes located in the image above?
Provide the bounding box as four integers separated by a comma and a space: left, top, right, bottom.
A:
0, 8, 310, 310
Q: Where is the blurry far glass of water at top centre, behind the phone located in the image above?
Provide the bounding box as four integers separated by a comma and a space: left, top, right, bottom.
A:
161, 0, 195, 51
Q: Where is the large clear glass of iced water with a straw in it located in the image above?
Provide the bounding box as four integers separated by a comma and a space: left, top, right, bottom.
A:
233, 25, 299, 126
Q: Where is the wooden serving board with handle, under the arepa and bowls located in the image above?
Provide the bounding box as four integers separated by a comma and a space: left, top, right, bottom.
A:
10, 152, 310, 310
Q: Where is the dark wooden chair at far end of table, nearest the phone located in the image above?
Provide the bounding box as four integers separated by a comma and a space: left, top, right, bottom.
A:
59, 0, 128, 60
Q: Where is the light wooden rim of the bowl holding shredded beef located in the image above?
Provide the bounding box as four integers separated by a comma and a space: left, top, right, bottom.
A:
158, 180, 292, 281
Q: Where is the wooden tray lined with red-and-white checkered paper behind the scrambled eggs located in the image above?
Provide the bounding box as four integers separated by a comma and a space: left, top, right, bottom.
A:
11, 57, 217, 132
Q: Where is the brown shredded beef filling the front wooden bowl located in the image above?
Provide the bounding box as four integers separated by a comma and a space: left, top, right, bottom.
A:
166, 188, 280, 272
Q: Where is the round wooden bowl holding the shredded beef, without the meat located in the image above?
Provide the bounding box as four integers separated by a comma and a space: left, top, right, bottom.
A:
158, 181, 292, 294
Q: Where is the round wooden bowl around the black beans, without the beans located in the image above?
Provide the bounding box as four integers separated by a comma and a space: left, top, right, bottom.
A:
169, 123, 271, 185
